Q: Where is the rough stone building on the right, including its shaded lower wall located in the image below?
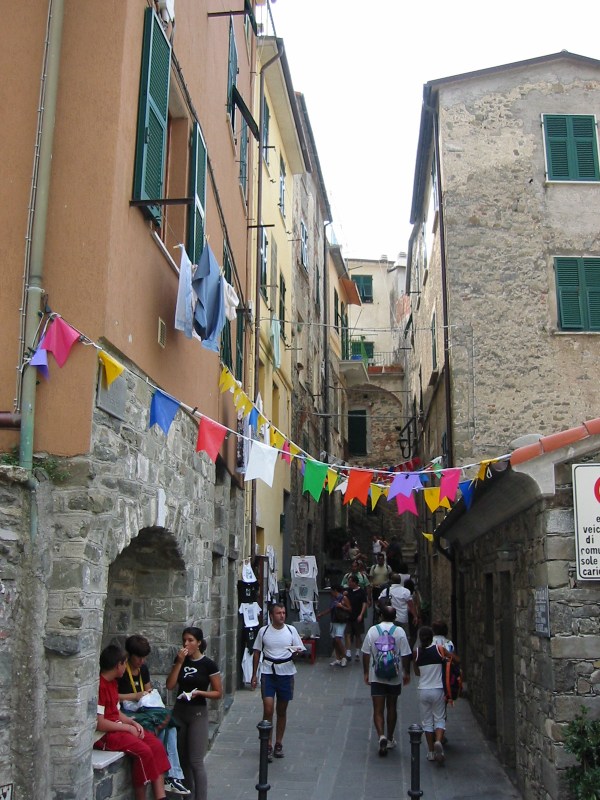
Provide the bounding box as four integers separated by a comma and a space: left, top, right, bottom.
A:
406, 51, 600, 800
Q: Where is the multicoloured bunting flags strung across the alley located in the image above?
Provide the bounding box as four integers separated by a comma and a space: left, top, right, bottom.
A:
22, 313, 510, 541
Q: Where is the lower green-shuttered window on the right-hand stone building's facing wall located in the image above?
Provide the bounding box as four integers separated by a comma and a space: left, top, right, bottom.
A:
554, 258, 600, 331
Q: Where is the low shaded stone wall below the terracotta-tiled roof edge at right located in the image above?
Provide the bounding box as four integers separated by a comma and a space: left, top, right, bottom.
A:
458, 466, 600, 800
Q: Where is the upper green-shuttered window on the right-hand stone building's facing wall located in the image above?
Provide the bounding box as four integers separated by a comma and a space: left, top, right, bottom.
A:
542, 114, 600, 181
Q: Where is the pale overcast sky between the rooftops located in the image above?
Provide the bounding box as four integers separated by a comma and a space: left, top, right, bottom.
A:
272, 0, 600, 258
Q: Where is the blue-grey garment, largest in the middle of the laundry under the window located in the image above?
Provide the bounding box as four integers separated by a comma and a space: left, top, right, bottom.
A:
192, 244, 225, 353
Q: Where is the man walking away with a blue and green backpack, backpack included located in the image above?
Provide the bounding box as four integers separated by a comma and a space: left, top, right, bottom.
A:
362, 606, 411, 757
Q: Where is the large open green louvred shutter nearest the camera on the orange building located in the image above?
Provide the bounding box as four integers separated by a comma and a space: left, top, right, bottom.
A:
133, 8, 171, 225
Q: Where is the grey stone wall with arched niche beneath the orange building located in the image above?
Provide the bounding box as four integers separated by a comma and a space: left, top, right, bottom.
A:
0, 364, 244, 800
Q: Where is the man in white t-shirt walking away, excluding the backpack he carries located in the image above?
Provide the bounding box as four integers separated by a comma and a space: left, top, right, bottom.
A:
362, 606, 411, 756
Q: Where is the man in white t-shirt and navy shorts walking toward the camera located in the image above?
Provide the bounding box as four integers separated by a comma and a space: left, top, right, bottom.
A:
250, 603, 306, 761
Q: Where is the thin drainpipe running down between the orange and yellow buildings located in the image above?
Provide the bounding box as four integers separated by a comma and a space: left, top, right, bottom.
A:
250, 39, 283, 558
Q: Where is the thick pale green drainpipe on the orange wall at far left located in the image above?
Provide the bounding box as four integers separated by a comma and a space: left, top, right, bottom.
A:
19, 0, 64, 473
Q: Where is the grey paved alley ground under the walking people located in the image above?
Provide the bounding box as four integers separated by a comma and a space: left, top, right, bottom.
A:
206, 658, 521, 800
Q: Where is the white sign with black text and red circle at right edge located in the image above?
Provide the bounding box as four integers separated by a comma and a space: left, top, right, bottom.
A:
573, 464, 600, 581
